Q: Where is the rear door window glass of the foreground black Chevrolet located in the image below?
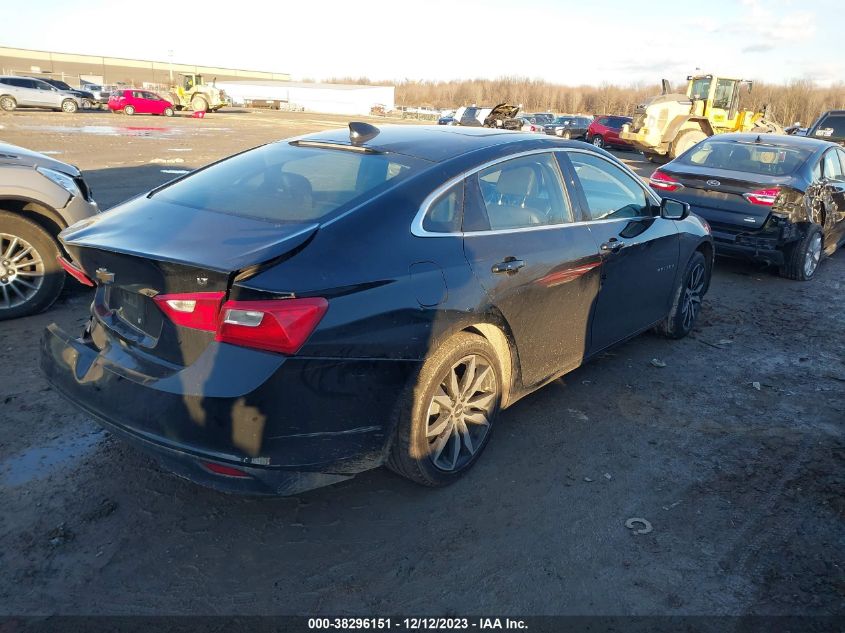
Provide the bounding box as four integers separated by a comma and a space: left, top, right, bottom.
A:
472, 154, 572, 231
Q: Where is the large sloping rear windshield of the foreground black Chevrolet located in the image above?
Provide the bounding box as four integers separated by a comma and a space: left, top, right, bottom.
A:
154, 142, 426, 222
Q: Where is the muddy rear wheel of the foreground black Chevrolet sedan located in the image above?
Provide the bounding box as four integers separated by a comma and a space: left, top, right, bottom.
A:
387, 332, 502, 487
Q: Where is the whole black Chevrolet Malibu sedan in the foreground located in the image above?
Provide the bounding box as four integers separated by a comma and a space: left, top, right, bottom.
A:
41, 123, 712, 494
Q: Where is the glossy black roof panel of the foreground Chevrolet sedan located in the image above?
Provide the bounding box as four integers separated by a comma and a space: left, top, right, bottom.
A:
296, 125, 567, 162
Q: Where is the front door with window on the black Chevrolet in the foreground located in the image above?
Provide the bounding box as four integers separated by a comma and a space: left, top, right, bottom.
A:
567, 150, 680, 353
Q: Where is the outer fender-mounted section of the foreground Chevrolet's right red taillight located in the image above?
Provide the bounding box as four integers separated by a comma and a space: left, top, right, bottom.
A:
216, 297, 329, 354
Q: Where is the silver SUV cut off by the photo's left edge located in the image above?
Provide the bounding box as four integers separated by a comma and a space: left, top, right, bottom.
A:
0, 143, 99, 321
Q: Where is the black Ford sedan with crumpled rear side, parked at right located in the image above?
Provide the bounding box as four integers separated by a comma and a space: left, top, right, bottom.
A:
650, 134, 845, 280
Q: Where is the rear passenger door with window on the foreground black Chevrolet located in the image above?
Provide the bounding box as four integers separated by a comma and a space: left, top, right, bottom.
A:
463, 152, 600, 386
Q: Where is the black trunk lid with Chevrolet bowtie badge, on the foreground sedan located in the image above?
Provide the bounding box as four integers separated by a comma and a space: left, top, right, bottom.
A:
60, 197, 319, 371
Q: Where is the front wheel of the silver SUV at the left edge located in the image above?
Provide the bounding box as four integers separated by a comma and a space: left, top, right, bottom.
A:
0, 211, 65, 321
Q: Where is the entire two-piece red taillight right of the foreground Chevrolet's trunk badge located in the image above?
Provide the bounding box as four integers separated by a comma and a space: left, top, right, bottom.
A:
154, 292, 329, 354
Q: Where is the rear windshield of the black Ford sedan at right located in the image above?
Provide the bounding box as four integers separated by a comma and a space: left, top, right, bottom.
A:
680, 141, 812, 176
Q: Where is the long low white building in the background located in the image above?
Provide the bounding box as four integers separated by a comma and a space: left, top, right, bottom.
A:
217, 80, 395, 114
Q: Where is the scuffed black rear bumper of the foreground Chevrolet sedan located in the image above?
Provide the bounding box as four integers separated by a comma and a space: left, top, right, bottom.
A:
41, 325, 418, 495
